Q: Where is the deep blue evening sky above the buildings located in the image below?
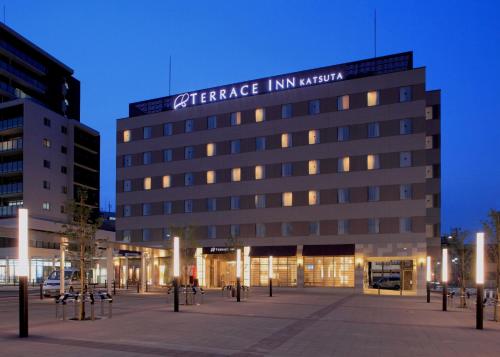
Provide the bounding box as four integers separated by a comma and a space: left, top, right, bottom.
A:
0, 0, 500, 231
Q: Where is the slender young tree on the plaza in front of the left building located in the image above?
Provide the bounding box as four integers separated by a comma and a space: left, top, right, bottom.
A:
61, 190, 101, 320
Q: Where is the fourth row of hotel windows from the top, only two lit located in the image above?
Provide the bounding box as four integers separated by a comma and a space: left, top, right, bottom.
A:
123, 184, 412, 217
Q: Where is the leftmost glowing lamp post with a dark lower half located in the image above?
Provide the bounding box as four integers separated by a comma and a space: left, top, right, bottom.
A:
17, 208, 29, 337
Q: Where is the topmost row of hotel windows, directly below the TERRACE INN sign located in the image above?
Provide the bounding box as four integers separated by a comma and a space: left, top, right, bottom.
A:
123, 86, 412, 143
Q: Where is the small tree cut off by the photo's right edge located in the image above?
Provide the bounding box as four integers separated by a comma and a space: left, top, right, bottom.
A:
483, 209, 500, 322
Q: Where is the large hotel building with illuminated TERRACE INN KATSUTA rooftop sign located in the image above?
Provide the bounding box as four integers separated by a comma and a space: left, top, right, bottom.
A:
116, 52, 440, 292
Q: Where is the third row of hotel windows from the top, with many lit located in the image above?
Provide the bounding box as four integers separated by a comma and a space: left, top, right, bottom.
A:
123, 151, 412, 192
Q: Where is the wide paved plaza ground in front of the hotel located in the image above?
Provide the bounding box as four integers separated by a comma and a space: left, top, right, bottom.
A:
0, 289, 500, 357
